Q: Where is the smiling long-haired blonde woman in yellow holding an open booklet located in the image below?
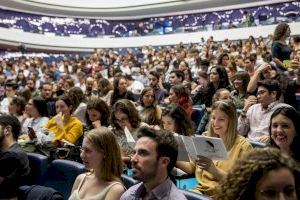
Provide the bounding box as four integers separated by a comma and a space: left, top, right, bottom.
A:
176, 100, 252, 196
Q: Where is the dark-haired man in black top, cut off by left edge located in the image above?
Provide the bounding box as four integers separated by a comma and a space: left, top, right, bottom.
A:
0, 115, 30, 199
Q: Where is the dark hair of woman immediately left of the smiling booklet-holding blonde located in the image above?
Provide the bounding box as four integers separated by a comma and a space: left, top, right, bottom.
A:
162, 103, 194, 135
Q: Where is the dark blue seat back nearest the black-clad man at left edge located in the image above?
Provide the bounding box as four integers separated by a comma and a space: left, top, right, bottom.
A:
27, 153, 48, 185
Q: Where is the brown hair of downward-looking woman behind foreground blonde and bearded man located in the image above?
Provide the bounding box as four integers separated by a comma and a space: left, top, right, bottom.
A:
110, 99, 141, 129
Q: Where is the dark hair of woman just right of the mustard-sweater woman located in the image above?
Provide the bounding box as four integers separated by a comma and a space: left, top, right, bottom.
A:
86, 98, 110, 127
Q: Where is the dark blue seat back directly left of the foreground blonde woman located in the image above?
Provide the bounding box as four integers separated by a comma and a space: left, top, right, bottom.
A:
43, 159, 86, 199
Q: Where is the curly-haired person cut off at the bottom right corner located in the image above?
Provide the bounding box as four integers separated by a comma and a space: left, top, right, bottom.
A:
214, 148, 300, 200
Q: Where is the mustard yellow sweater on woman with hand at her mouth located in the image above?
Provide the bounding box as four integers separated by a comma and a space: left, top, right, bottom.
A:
45, 117, 83, 144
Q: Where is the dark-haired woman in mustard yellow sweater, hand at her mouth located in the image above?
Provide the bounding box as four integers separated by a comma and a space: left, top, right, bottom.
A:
45, 95, 83, 144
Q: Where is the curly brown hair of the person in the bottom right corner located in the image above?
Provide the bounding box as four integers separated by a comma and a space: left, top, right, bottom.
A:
214, 148, 300, 200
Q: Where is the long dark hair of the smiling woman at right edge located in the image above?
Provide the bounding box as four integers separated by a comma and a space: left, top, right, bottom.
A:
269, 107, 300, 162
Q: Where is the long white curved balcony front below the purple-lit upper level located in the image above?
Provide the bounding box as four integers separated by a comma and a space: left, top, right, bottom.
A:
0, 22, 300, 52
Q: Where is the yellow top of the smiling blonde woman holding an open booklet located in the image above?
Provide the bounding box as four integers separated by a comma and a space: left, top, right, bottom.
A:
190, 135, 252, 196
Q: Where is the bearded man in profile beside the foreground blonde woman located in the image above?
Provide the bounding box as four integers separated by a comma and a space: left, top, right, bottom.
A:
121, 127, 186, 200
